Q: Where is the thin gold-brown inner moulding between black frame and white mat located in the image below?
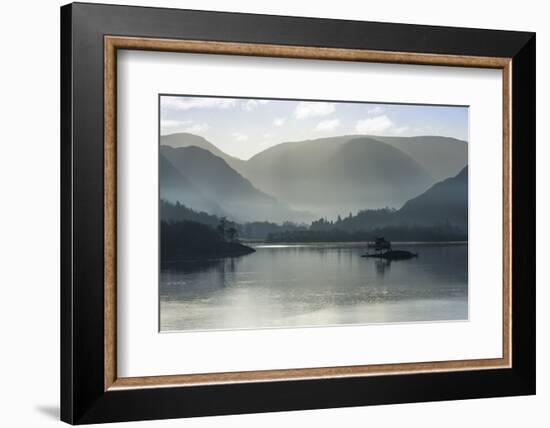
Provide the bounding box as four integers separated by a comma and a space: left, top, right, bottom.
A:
104, 36, 512, 391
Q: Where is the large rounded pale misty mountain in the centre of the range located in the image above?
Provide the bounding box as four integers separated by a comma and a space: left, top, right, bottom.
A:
243, 136, 434, 216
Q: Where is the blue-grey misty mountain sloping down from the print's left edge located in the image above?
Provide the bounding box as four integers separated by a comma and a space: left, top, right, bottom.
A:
160, 146, 306, 221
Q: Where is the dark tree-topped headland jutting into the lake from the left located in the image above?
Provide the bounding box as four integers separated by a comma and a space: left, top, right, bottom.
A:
160, 218, 255, 262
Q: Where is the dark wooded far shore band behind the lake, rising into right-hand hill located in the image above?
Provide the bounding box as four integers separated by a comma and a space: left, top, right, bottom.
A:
161, 161, 468, 242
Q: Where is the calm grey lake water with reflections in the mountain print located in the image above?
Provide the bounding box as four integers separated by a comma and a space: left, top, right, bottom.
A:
160, 243, 468, 331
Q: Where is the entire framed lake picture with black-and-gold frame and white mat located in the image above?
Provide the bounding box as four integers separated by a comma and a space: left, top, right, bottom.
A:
61, 3, 535, 424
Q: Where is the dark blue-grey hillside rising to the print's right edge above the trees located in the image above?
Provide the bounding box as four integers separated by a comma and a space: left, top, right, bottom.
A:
396, 167, 468, 230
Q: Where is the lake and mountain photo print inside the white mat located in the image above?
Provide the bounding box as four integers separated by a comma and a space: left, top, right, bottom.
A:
159, 94, 468, 332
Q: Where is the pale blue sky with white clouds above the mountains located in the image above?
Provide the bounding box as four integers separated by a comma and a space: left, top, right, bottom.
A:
160, 95, 468, 159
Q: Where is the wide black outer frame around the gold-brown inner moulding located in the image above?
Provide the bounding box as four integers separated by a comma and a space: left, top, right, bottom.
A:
61, 3, 536, 424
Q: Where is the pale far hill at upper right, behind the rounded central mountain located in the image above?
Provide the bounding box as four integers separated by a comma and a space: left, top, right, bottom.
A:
371, 136, 468, 181
